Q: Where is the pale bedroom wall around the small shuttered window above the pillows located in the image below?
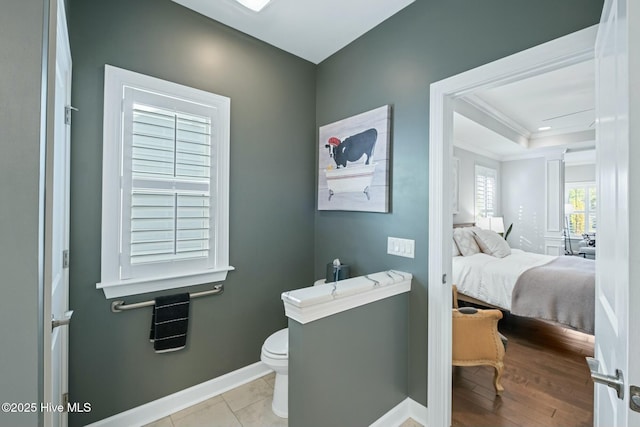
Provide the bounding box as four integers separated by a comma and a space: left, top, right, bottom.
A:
453, 147, 502, 224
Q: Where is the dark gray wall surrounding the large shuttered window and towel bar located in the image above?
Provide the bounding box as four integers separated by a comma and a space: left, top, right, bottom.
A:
69, 0, 316, 426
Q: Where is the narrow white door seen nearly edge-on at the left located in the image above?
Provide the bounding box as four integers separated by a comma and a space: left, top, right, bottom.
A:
43, 0, 71, 427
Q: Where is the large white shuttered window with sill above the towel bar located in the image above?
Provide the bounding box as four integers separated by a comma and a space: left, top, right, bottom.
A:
97, 65, 233, 298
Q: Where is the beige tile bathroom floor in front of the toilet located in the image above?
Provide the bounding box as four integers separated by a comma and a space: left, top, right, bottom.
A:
145, 373, 422, 427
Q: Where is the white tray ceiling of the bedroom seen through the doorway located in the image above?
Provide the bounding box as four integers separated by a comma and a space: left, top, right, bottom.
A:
454, 61, 595, 160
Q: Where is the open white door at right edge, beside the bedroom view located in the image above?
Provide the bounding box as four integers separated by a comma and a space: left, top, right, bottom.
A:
590, 0, 640, 427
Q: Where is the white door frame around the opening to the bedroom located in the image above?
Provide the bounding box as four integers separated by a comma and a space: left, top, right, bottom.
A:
427, 25, 597, 426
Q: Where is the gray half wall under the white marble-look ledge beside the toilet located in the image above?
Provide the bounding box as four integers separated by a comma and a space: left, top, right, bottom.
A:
289, 296, 408, 427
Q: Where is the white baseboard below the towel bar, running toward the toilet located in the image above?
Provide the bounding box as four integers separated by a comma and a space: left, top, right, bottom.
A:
89, 362, 271, 427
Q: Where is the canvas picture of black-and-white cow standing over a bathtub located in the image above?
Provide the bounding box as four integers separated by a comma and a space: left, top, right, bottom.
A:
318, 105, 391, 212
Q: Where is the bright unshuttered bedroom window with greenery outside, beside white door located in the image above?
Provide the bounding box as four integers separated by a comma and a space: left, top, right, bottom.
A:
565, 182, 598, 236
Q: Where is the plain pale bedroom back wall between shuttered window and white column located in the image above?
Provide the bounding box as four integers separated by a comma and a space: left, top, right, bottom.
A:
501, 157, 547, 254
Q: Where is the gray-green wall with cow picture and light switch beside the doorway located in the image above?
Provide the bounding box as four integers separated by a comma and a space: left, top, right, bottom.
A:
315, 0, 602, 404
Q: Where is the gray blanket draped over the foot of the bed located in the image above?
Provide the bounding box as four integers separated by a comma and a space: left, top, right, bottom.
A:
511, 256, 595, 334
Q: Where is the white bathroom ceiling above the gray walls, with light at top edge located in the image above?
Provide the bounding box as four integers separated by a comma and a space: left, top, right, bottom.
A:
173, 0, 415, 64
